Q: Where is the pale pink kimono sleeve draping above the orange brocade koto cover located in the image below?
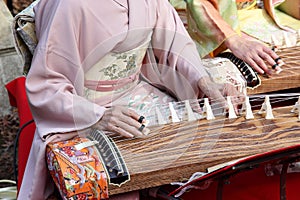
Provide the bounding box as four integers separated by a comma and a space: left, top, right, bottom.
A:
26, 0, 105, 138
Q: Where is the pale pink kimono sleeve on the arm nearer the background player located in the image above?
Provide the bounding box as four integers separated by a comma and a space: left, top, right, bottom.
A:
147, 0, 208, 100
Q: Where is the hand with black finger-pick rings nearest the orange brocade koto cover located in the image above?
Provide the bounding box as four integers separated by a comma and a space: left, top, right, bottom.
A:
93, 106, 150, 138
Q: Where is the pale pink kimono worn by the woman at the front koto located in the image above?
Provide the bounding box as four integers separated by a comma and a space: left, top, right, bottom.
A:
19, 0, 207, 200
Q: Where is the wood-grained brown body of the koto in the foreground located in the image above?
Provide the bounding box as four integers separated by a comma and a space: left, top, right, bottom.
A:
109, 106, 300, 194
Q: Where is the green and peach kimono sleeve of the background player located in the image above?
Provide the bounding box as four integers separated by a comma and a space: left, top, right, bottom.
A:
187, 0, 239, 57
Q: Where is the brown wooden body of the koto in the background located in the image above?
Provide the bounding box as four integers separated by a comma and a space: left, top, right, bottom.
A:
247, 46, 300, 94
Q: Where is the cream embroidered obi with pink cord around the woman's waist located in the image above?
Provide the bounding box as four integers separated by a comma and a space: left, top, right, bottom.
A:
84, 35, 151, 101
